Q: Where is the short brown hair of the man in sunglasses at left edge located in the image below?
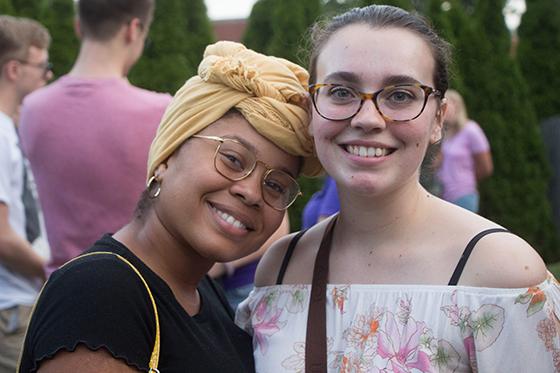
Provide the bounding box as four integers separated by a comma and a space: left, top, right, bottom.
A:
0, 15, 51, 68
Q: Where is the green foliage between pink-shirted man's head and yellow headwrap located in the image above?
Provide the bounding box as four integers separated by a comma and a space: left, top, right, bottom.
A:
130, 0, 214, 94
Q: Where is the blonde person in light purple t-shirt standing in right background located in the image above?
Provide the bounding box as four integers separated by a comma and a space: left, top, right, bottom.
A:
438, 90, 493, 212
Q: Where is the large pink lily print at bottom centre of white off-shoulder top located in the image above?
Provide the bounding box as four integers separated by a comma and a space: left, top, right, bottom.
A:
377, 313, 432, 373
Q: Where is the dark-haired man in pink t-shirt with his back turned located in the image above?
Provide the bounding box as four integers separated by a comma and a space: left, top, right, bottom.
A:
21, 0, 171, 273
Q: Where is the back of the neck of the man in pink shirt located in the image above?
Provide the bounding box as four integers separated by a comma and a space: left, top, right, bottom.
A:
69, 38, 128, 79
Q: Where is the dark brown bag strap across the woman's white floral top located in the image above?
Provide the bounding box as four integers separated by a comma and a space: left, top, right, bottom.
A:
305, 216, 338, 373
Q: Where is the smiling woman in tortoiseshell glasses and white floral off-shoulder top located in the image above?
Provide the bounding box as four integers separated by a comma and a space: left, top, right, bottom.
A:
237, 5, 560, 373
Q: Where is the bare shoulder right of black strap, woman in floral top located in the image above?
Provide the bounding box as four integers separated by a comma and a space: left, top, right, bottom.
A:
461, 228, 547, 288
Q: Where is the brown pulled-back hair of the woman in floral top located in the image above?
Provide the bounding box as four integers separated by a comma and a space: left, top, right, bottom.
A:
309, 5, 451, 93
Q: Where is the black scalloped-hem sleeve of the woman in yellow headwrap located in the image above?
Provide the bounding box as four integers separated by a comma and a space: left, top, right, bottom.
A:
22, 251, 155, 367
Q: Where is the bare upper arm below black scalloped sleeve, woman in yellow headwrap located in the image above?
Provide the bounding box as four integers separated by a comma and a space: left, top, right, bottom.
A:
38, 346, 139, 373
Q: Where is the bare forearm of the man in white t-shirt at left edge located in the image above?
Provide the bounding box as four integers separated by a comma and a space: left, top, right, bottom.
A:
0, 202, 45, 281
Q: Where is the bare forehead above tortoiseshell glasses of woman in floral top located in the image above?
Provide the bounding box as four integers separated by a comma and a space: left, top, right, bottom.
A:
317, 24, 435, 90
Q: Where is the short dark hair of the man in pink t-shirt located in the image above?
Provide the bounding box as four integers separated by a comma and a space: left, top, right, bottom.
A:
77, 0, 155, 41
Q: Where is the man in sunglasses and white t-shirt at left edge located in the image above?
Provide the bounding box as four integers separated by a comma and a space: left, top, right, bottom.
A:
0, 15, 52, 373
